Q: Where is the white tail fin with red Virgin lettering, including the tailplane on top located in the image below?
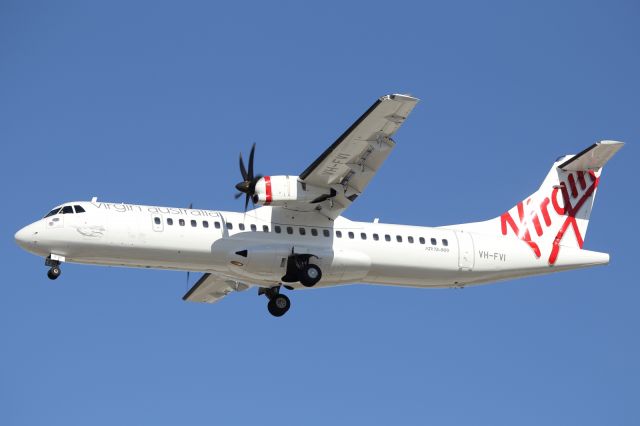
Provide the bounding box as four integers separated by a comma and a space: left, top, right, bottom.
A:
454, 141, 624, 265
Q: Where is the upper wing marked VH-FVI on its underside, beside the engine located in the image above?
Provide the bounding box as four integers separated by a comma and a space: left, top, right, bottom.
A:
300, 95, 418, 219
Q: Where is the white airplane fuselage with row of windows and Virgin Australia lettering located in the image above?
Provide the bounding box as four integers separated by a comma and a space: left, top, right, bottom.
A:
16, 201, 609, 287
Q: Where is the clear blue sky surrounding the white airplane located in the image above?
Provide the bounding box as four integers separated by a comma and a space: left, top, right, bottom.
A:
0, 1, 640, 426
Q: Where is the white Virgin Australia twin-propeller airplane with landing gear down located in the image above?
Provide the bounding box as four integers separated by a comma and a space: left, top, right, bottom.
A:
15, 94, 623, 317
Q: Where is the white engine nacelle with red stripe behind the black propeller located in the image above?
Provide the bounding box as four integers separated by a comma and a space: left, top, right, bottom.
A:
253, 176, 328, 206
